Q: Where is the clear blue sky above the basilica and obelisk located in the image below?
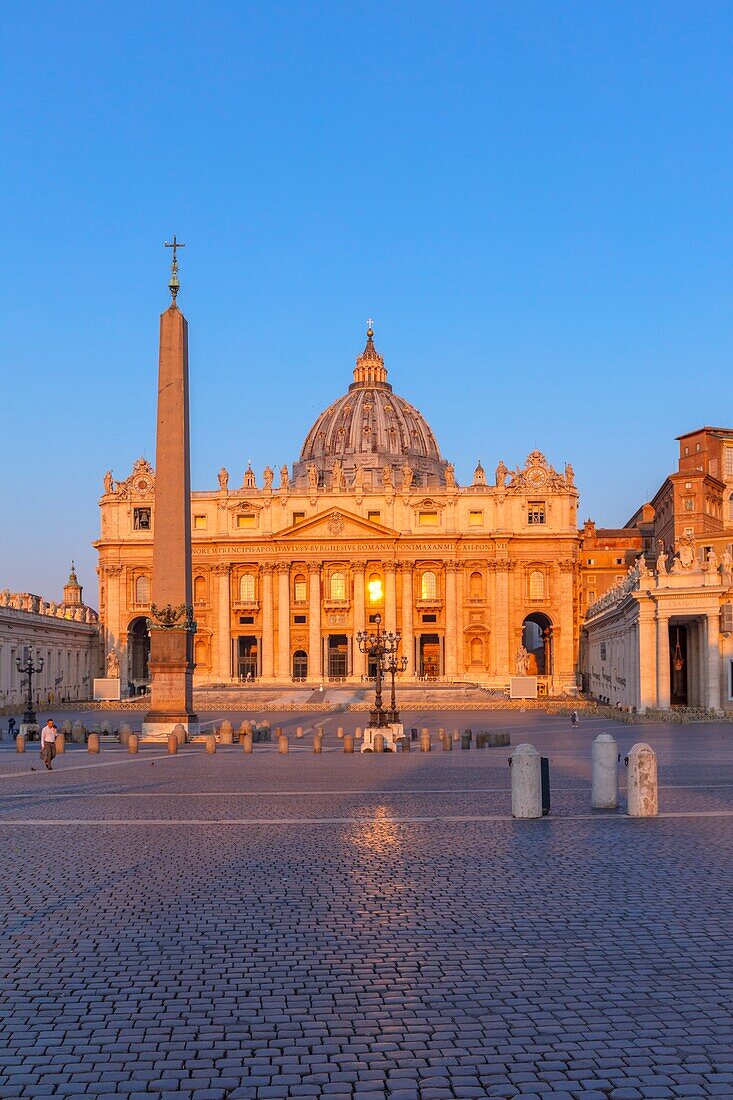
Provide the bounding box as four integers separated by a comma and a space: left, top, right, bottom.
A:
0, 0, 733, 603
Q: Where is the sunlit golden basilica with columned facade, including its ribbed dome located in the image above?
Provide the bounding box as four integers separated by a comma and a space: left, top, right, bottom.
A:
96, 328, 580, 693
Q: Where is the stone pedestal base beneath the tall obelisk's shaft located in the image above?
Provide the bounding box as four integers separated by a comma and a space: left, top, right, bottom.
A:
142, 627, 199, 741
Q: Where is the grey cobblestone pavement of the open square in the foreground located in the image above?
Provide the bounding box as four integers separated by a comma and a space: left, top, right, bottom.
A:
0, 714, 733, 1100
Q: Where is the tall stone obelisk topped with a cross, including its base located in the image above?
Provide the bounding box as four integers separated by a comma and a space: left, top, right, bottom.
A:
143, 237, 198, 739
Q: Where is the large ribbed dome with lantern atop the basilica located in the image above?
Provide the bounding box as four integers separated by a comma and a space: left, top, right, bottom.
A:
293, 328, 447, 487
